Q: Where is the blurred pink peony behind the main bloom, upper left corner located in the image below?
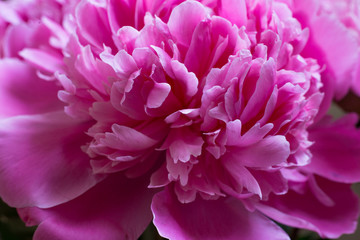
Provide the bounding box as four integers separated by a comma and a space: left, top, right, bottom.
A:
0, 0, 69, 118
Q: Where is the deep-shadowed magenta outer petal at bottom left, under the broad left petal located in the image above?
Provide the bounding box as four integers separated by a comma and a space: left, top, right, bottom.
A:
19, 172, 155, 240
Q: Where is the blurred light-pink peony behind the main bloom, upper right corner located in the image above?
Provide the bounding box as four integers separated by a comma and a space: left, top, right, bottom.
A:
288, 0, 360, 102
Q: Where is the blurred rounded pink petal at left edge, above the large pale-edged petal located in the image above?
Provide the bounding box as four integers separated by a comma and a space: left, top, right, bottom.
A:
0, 58, 62, 118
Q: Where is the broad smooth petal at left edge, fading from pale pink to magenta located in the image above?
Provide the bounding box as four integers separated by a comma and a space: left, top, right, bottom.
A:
0, 112, 100, 207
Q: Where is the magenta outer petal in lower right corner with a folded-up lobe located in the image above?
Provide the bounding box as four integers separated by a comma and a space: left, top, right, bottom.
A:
256, 178, 359, 238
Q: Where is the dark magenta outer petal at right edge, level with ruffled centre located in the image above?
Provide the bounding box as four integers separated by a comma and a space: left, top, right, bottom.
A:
305, 115, 360, 183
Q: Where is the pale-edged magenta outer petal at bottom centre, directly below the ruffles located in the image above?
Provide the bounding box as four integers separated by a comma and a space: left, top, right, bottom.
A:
151, 190, 289, 240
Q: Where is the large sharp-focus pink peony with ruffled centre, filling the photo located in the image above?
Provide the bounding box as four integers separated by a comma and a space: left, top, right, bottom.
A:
0, 0, 360, 240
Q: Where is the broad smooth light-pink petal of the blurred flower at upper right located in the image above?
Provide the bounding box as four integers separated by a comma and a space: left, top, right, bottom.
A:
294, 0, 358, 98
